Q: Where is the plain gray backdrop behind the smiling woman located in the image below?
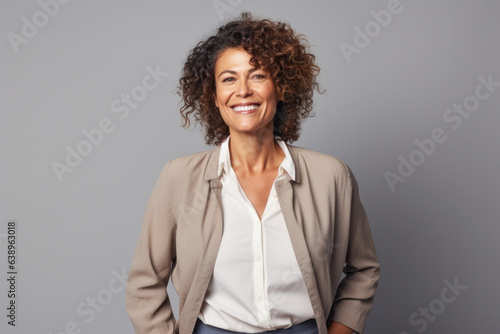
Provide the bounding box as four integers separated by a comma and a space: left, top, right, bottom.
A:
0, 0, 500, 334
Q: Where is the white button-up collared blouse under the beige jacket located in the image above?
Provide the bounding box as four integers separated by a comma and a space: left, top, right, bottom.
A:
198, 136, 314, 333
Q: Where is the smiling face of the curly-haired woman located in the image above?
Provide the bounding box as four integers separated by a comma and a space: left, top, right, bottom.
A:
215, 48, 278, 135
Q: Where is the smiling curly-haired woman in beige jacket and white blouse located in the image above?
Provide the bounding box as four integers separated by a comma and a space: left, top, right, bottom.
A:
127, 13, 379, 334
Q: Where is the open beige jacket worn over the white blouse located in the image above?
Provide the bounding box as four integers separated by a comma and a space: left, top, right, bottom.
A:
126, 144, 380, 334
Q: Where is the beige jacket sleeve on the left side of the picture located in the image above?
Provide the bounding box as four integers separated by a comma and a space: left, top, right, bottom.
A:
126, 161, 176, 334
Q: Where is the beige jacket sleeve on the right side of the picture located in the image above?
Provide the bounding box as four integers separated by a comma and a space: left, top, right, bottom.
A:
332, 165, 380, 333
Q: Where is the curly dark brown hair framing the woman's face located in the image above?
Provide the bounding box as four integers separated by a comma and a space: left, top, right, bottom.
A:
177, 12, 324, 145
